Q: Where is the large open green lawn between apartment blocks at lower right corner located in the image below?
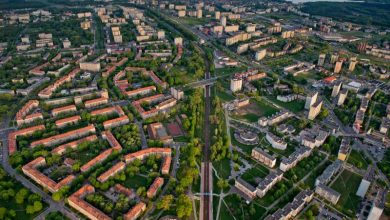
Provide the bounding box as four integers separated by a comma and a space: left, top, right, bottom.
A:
331, 170, 362, 216
